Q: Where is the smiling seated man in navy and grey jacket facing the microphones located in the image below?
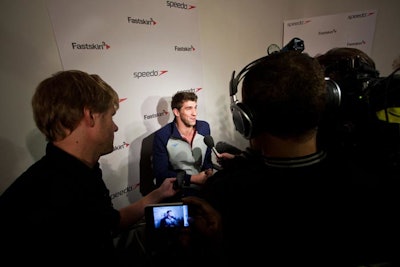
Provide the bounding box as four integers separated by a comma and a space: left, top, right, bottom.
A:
152, 92, 213, 199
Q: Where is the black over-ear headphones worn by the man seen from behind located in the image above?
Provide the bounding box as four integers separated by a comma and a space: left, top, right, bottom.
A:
229, 54, 341, 139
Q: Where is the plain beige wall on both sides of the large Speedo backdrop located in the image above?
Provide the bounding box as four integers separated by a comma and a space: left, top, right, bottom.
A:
0, 0, 400, 196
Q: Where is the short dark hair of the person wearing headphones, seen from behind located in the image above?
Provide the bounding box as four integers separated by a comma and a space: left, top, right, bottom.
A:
242, 51, 327, 137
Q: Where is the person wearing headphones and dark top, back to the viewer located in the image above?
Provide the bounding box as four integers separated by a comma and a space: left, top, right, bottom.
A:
202, 51, 399, 266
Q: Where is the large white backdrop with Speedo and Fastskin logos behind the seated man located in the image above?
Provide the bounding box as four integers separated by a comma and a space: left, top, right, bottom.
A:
47, 0, 205, 208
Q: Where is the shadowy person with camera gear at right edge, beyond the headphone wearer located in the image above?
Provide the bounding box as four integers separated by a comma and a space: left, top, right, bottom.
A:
316, 47, 400, 182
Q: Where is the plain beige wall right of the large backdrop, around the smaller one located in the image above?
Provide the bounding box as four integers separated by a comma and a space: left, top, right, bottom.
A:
200, 0, 400, 153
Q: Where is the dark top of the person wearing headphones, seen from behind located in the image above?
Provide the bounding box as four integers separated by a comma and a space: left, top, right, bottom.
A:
202, 149, 400, 266
